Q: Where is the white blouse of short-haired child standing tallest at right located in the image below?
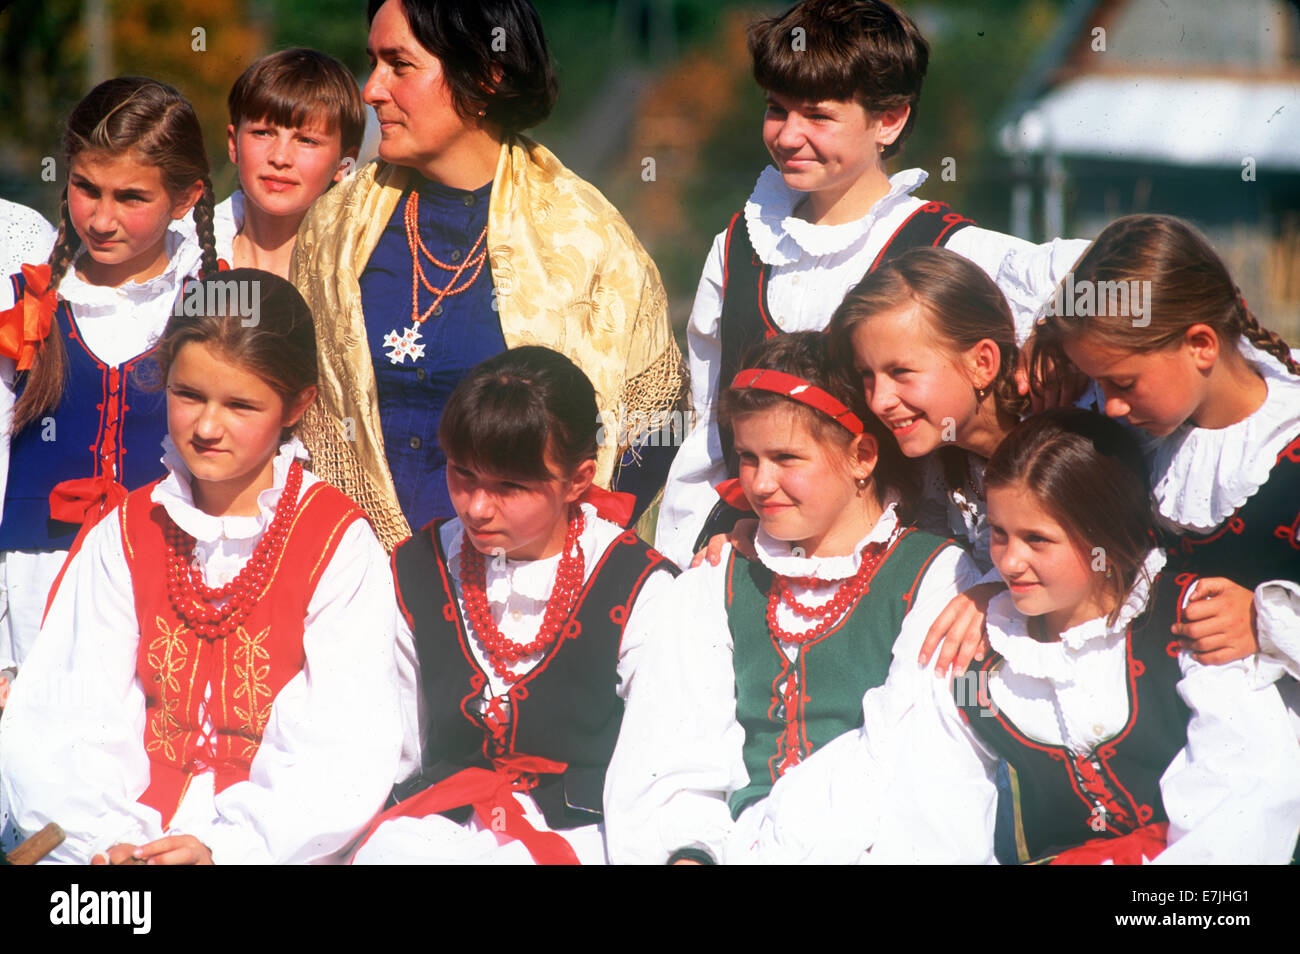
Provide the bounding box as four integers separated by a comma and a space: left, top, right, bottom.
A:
655, 166, 1088, 565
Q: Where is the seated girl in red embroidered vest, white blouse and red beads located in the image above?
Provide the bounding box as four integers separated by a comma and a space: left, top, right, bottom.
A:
0, 269, 400, 864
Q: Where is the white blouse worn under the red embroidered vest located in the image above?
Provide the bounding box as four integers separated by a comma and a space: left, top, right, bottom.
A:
0, 439, 402, 864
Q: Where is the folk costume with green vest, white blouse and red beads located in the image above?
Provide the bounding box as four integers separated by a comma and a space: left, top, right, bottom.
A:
605, 503, 979, 864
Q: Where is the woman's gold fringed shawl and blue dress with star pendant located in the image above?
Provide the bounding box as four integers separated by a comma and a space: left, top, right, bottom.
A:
293, 136, 684, 550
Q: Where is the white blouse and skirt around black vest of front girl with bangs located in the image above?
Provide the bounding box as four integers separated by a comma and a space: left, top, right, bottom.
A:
355, 504, 672, 864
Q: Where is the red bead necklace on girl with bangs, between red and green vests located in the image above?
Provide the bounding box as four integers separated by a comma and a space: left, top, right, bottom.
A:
460, 507, 586, 684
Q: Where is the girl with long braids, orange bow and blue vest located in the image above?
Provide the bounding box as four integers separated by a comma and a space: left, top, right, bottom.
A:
0, 77, 217, 702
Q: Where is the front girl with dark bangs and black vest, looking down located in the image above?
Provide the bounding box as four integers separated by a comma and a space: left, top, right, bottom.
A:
355, 347, 676, 864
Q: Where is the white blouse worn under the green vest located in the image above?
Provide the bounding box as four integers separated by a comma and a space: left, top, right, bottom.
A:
605, 507, 979, 864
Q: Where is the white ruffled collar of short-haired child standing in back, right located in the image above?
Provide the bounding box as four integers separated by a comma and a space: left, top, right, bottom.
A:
745, 165, 928, 265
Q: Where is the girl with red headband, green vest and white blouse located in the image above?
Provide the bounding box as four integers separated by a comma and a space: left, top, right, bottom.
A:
606, 331, 979, 863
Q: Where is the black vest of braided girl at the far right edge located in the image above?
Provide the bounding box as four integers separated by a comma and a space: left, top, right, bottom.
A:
1169, 435, 1300, 590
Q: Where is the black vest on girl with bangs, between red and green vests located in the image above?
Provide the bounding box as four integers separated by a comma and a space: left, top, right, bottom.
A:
393, 521, 677, 829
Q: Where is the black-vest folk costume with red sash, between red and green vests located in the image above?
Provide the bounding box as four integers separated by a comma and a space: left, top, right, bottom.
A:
356, 504, 676, 864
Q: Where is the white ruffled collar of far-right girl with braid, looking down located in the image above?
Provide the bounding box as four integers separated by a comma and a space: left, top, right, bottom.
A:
1152, 338, 1300, 533
